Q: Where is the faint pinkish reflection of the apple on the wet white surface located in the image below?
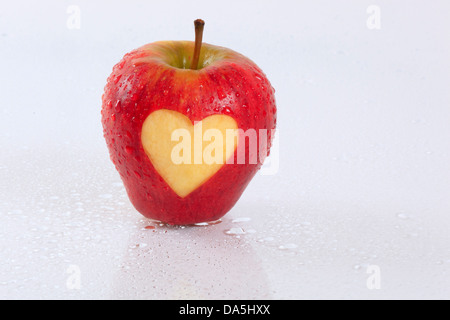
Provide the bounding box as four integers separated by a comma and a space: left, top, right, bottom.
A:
111, 211, 270, 299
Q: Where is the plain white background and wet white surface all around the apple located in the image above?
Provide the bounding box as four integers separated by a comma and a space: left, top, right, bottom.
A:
0, 0, 450, 299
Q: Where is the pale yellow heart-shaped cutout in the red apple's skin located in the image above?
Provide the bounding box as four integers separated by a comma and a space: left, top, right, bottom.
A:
141, 109, 238, 198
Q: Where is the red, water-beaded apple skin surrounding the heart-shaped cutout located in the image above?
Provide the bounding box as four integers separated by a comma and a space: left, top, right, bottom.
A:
101, 41, 276, 225
